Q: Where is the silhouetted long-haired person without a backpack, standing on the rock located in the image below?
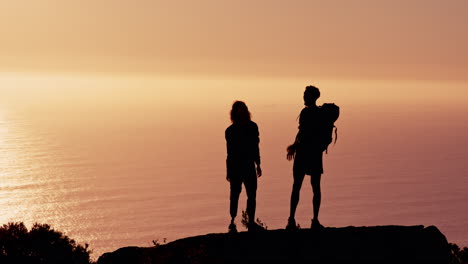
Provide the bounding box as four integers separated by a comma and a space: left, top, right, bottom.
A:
225, 101, 263, 232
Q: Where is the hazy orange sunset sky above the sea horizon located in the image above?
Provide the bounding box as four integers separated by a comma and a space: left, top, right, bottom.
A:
0, 0, 468, 80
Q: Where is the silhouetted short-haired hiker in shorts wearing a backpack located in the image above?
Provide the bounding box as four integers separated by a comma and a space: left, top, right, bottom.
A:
286, 86, 339, 230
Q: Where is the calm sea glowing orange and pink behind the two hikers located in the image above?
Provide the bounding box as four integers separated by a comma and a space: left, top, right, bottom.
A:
0, 76, 468, 258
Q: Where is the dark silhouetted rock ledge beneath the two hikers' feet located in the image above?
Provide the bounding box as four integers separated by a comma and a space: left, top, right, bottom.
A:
98, 226, 450, 264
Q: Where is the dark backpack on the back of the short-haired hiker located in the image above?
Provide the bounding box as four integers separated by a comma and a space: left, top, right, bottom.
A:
320, 103, 340, 154
